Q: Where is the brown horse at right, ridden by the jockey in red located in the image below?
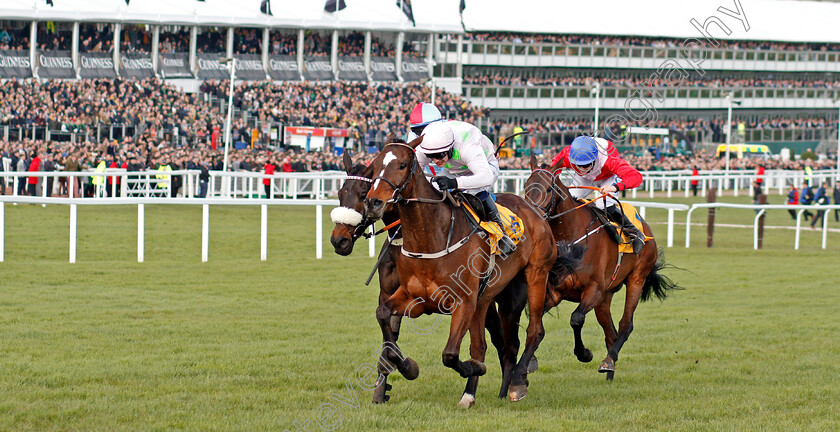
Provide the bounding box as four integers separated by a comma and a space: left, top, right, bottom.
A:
524, 156, 679, 380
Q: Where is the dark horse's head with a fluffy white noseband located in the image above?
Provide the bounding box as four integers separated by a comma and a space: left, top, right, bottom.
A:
330, 152, 373, 255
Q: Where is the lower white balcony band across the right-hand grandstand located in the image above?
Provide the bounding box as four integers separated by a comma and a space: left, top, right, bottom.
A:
463, 84, 840, 110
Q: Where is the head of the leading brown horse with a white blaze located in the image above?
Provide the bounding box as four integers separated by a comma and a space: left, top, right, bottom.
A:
365, 136, 423, 220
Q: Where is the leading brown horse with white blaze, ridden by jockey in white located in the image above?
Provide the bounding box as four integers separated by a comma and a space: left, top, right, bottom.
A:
365, 137, 576, 406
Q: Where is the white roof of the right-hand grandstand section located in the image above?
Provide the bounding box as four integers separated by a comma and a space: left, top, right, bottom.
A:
462, 0, 840, 42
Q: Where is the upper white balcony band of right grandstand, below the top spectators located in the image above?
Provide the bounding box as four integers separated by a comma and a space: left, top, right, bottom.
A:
435, 38, 840, 72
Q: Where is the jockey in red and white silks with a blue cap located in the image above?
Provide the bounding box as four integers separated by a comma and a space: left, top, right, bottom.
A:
551, 135, 645, 254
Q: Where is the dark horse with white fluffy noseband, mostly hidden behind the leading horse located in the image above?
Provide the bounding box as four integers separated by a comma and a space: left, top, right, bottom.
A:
330, 139, 537, 403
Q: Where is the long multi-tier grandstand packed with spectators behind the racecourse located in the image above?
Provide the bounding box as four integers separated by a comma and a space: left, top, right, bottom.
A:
0, 0, 840, 164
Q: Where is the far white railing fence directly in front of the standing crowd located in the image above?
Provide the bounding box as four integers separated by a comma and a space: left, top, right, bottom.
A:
2, 169, 838, 200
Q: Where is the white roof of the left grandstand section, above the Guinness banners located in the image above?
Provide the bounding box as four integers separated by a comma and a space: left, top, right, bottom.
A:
0, 0, 463, 33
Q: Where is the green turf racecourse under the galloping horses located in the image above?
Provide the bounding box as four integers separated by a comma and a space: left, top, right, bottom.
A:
0, 197, 840, 431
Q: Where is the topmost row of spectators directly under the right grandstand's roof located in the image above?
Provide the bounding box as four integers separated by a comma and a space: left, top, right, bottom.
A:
466, 32, 840, 51
